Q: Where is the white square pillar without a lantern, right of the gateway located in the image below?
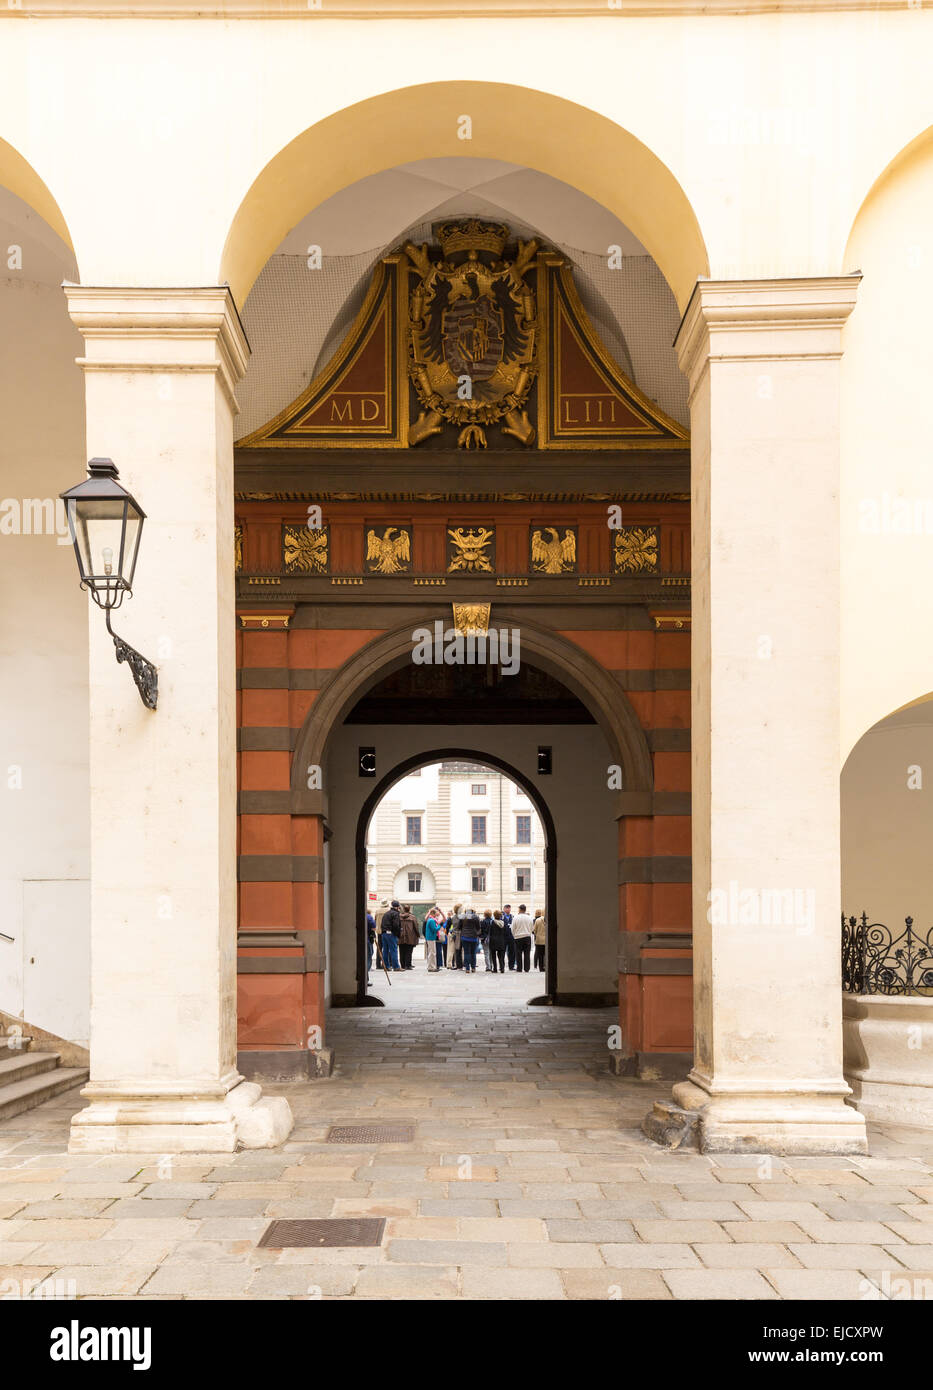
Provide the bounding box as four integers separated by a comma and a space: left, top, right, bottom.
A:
674, 277, 865, 1154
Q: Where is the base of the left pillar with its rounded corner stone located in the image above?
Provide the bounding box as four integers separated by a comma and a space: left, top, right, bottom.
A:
68, 1077, 295, 1154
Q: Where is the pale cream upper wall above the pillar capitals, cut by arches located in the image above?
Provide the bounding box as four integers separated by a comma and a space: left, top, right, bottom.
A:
0, 3, 933, 285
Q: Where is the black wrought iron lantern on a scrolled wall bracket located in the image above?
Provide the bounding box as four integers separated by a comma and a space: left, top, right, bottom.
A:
61, 459, 159, 709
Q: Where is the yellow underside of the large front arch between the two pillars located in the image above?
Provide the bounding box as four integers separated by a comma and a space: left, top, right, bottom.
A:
218, 82, 709, 310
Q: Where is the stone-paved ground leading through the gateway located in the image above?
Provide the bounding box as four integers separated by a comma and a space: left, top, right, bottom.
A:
0, 960, 933, 1300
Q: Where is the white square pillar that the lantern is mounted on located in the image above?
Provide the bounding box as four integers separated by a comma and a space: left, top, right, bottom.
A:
65, 286, 292, 1154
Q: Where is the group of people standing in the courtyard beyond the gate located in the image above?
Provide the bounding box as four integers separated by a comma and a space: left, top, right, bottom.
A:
366, 898, 548, 974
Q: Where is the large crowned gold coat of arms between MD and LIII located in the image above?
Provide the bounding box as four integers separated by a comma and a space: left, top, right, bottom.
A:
405, 218, 538, 449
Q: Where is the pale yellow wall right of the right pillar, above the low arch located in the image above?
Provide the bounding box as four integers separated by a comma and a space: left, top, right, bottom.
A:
841, 136, 933, 758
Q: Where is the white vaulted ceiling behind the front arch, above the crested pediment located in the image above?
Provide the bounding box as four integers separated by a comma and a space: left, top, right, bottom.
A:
236, 157, 688, 438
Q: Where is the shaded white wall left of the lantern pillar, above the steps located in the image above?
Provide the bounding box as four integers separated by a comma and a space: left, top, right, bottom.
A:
0, 190, 89, 1045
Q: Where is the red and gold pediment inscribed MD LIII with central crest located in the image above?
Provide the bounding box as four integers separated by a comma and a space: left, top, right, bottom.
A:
238, 218, 688, 452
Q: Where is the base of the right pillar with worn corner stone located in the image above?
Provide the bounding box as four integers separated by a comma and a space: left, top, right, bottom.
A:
645, 1081, 868, 1155
